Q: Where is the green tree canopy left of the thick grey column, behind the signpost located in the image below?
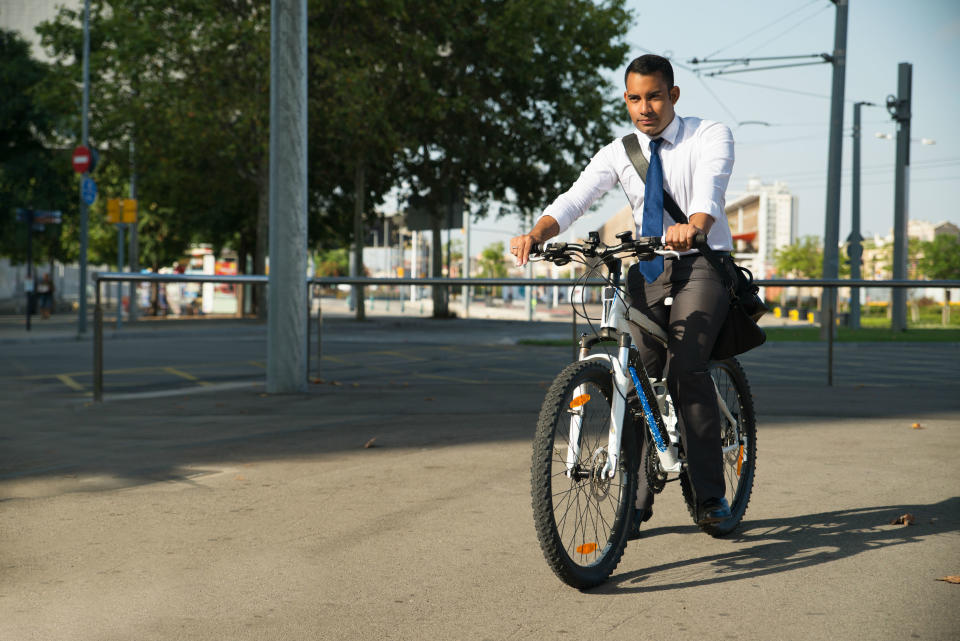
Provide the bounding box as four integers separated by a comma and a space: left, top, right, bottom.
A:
38, 0, 270, 308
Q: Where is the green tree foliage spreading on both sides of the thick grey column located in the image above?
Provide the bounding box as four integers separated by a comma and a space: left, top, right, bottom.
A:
26, 0, 631, 312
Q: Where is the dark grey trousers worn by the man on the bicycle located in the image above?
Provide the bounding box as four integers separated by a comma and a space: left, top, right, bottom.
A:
627, 254, 730, 508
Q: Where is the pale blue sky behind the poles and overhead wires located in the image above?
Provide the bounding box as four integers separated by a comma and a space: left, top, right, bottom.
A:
471, 0, 960, 251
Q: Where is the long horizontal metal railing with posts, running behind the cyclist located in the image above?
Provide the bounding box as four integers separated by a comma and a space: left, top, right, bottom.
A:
93, 272, 960, 402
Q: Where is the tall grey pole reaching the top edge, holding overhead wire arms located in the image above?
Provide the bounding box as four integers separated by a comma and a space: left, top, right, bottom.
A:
820, 0, 848, 339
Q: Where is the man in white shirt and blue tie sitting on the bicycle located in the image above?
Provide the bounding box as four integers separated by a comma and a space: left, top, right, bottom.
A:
510, 55, 734, 538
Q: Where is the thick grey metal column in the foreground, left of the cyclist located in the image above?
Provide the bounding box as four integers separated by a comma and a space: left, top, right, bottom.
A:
267, 0, 308, 394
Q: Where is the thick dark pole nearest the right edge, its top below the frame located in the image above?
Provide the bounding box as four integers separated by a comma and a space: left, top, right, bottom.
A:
887, 62, 913, 332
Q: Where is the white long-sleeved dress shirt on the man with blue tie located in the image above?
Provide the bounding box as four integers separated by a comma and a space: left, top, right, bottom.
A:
540, 115, 733, 253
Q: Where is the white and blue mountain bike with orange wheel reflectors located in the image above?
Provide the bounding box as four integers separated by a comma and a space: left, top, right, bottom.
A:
531, 232, 757, 589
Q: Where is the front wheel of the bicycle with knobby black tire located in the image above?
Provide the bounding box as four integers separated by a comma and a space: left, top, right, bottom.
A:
530, 361, 637, 590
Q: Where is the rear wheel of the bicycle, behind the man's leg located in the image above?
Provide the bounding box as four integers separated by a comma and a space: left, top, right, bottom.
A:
680, 358, 757, 538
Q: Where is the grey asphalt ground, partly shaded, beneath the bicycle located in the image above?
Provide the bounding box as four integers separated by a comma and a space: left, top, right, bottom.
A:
0, 308, 960, 640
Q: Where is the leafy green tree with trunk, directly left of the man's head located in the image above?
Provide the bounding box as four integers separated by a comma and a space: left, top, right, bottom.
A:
402, 0, 631, 316
